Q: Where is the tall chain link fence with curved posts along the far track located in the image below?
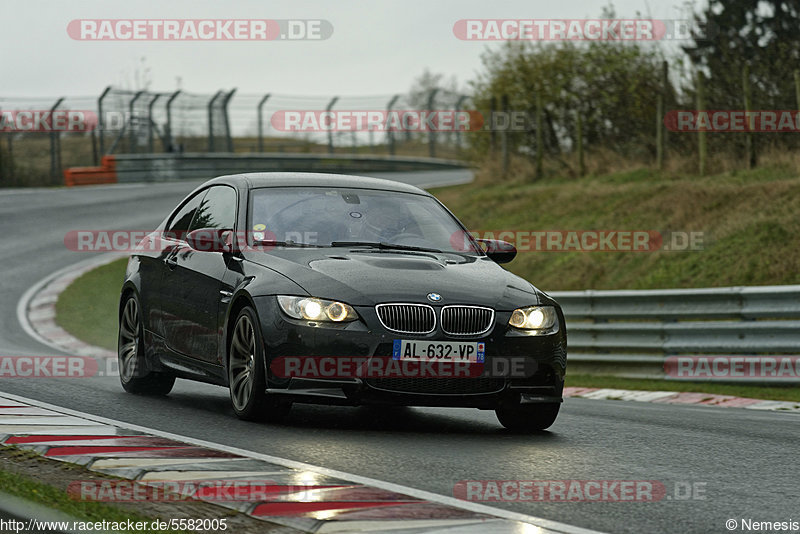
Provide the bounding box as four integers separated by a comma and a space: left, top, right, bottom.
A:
0, 87, 470, 187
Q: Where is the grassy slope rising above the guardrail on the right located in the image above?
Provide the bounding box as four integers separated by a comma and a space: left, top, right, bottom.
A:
434, 166, 800, 291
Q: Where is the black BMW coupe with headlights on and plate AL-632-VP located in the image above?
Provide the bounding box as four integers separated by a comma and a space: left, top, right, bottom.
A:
119, 173, 566, 431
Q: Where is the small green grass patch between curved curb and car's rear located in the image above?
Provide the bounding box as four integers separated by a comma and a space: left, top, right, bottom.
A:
56, 258, 128, 350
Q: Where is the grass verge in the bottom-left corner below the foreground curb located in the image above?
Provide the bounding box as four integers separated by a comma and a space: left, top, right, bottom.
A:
0, 462, 175, 532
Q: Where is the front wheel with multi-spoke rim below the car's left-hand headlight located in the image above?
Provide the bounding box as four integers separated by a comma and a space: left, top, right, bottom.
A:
228, 306, 292, 422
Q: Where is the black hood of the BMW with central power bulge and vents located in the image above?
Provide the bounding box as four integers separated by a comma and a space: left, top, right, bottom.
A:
246, 249, 539, 310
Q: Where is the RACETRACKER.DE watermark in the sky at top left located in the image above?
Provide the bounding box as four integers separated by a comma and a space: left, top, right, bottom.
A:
67, 19, 333, 41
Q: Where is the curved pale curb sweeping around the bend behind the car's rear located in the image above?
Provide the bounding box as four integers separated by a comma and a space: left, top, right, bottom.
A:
17, 253, 124, 358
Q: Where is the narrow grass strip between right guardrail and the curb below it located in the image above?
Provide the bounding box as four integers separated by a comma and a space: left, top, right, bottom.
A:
566, 376, 800, 402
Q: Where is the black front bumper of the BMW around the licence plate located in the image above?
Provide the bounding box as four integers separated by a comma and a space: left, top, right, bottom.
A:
256, 297, 567, 409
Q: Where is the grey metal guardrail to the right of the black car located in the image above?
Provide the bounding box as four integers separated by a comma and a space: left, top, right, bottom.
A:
551, 285, 800, 382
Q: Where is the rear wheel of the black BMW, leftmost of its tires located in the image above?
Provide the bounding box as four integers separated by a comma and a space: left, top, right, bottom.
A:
117, 294, 175, 395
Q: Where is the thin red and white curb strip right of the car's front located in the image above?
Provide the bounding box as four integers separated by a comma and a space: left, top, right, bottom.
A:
564, 387, 800, 413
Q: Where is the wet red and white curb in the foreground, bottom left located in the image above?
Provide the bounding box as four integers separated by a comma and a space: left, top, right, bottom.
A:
0, 393, 595, 534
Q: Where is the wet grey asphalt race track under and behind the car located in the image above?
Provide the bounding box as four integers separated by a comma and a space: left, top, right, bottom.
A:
0, 171, 800, 533
